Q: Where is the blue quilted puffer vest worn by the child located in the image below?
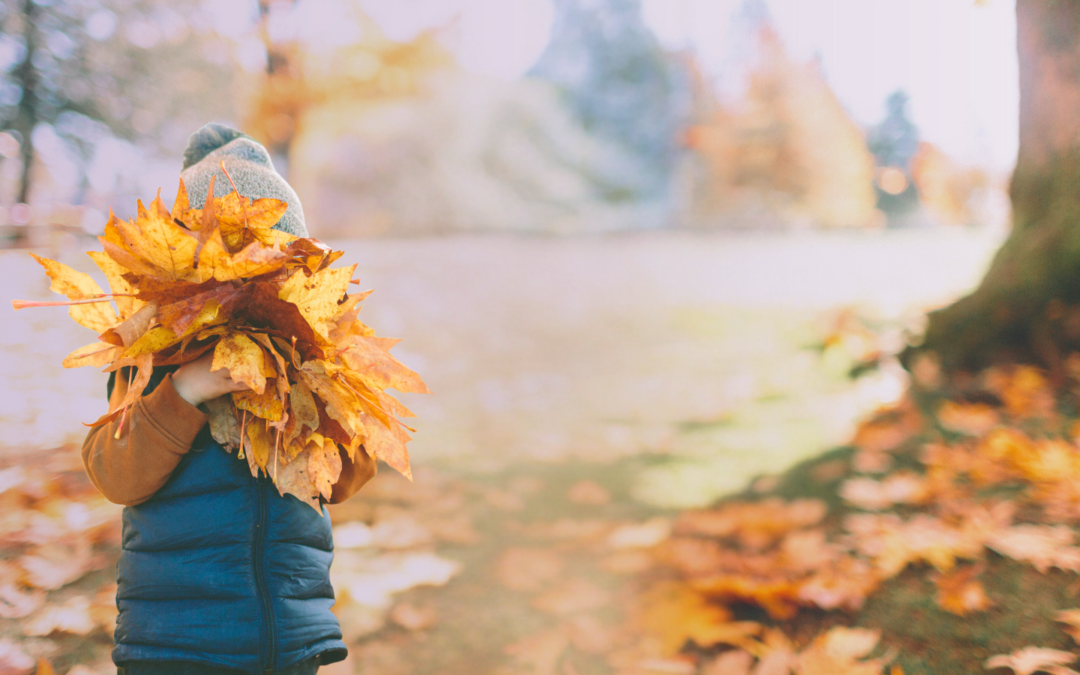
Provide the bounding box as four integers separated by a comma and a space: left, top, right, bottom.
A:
109, 368, 347, 673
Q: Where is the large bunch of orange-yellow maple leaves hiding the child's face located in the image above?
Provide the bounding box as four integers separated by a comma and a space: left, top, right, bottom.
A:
13, 181, 430, 510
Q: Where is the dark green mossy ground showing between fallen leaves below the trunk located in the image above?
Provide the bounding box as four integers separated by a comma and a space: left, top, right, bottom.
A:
725, 419, 1080, 675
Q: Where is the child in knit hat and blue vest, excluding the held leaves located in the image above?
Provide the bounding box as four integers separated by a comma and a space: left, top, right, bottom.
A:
82, 124, 375, 675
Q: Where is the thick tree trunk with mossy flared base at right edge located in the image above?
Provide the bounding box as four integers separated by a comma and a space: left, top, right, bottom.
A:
903, 0, 1080, 374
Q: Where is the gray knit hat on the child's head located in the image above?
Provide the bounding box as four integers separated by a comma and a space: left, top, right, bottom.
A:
174, 123, 308, 237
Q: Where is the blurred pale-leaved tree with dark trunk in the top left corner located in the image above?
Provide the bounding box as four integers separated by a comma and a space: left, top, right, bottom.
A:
0, 0, 235, 216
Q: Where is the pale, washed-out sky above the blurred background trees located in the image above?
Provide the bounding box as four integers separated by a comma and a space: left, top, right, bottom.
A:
349, 0, 1020, 173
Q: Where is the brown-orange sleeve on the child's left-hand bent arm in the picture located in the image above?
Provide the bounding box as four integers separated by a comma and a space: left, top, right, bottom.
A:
82, 375, 207, 507
